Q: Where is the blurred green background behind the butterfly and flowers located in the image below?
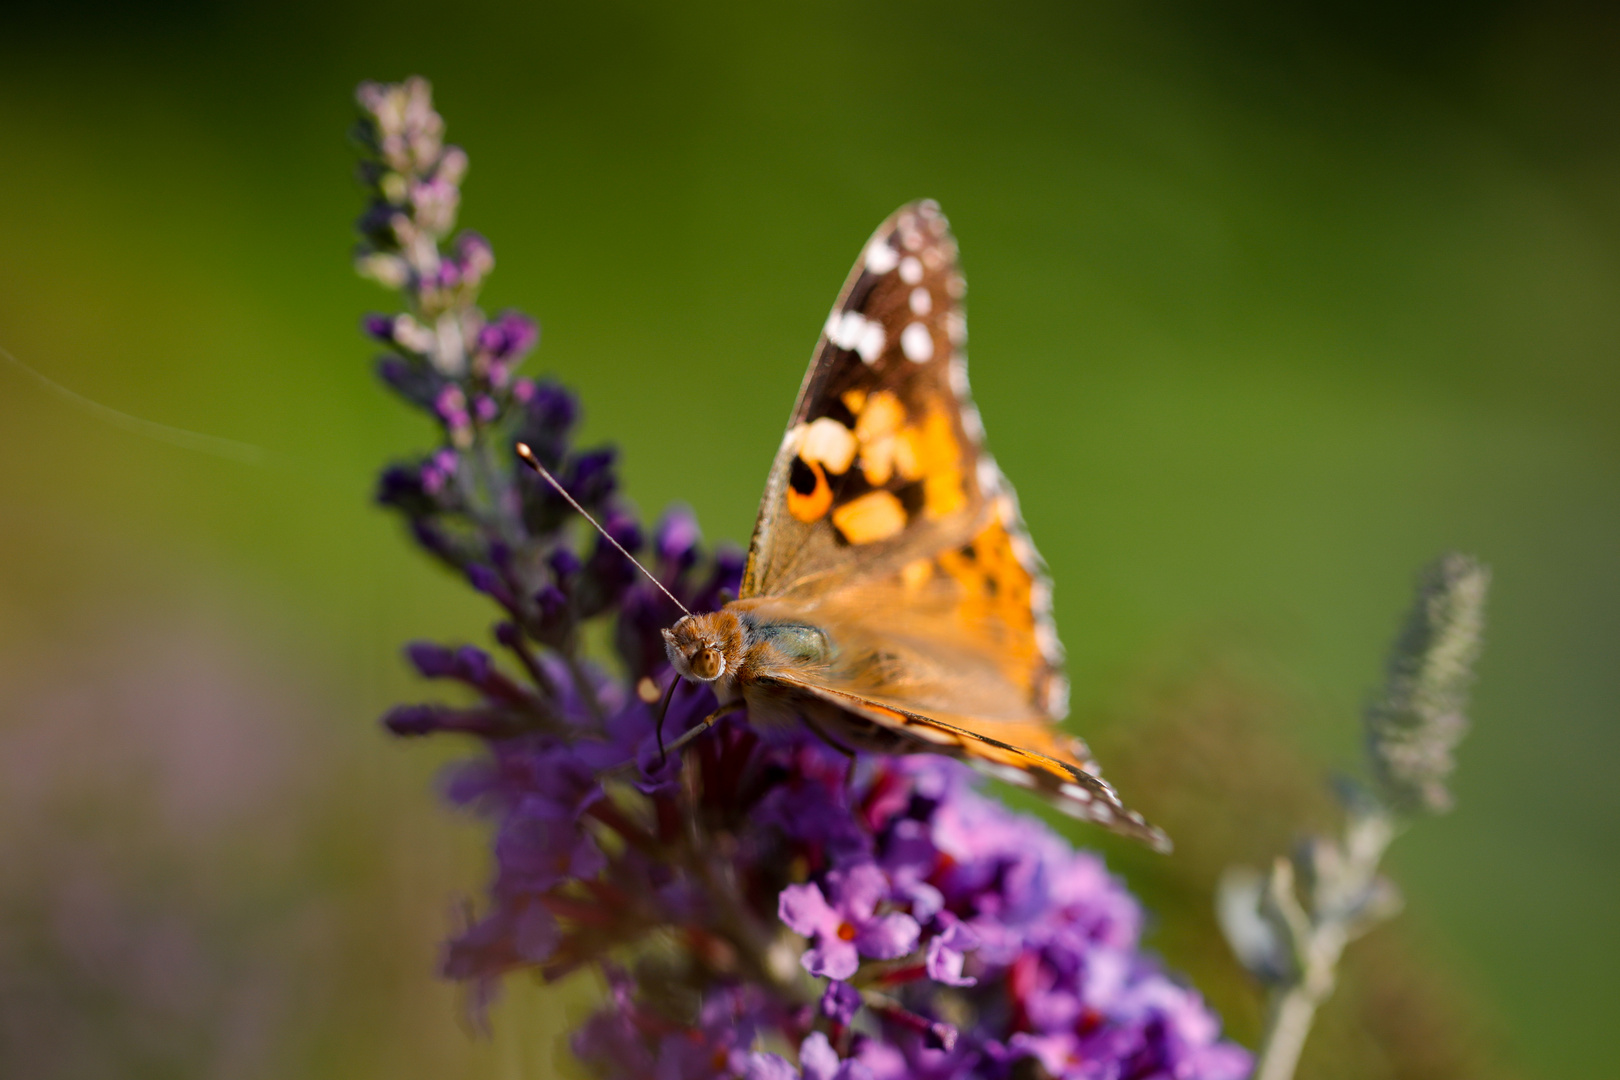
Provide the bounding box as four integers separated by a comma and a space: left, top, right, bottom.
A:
0, 0, 1620, 1078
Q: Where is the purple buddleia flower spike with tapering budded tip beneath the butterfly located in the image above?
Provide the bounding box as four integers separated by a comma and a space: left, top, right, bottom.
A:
358, 79, 1251, 1080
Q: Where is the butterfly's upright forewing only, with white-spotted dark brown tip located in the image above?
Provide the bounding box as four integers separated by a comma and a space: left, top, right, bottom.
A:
742, 204, 983, 596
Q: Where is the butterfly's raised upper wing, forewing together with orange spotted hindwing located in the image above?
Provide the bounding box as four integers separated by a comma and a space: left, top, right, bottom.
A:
740, 201, 1068, 719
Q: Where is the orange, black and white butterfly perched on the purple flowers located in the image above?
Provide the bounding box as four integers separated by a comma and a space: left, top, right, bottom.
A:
651, 201, 1168, 848
